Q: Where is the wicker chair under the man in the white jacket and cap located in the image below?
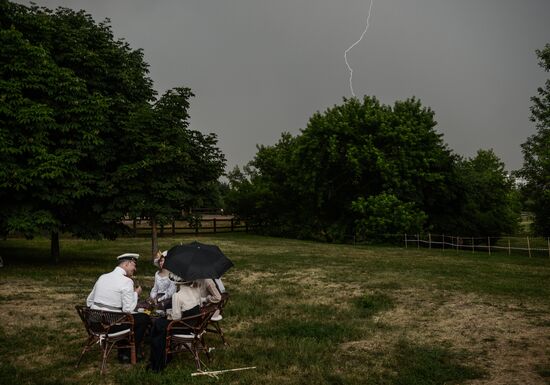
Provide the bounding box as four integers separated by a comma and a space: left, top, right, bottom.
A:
75, 305, 136, 374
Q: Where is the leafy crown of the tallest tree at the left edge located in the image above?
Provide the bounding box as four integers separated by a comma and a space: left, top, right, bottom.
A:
0, 1, 154, 243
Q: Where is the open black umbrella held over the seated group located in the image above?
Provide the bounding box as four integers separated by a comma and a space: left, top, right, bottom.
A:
164, 242, 233, 281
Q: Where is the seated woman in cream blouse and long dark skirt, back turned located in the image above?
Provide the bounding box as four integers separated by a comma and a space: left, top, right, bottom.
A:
147, 273, 201, 372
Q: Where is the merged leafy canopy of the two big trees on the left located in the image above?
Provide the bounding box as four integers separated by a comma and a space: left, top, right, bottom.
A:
0, 0, 224, 257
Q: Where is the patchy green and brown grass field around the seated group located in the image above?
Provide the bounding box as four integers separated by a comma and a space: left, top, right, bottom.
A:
0, 234, 550, 385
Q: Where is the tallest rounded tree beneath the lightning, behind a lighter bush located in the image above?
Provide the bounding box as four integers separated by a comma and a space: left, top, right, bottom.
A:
297, 97, 457, 238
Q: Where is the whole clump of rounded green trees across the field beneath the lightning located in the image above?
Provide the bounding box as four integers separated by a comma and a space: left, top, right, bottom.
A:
227, 97, 517, 241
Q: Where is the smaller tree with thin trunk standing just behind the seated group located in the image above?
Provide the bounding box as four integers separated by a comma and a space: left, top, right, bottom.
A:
108, 87, 225, 255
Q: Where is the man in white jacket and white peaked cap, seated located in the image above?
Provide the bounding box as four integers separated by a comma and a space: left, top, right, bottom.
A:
86, 253, 151, 362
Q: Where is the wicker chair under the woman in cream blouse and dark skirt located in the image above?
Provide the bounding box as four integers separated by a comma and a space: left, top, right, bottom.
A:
166, 304, 218, 370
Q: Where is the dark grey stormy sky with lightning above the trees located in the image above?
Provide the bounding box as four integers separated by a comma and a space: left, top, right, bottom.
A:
20, 0, 550, 170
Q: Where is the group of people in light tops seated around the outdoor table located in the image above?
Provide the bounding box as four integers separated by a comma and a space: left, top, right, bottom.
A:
86, 251, 225, 371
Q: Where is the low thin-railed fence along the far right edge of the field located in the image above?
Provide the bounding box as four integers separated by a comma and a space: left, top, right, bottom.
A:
404, 233, 550, 258
